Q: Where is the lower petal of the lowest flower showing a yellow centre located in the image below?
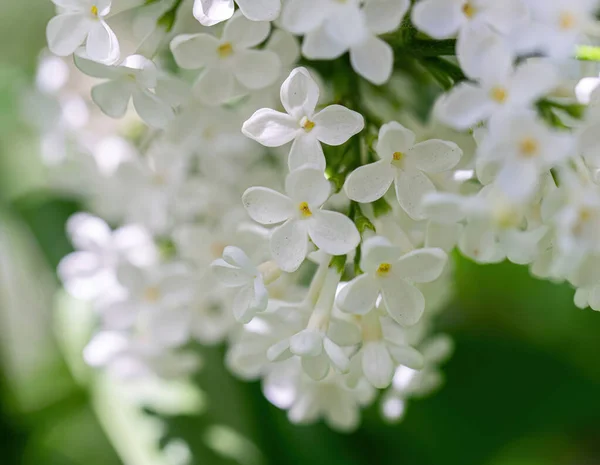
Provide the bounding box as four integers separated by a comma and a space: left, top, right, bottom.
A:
379, 276, 425, 326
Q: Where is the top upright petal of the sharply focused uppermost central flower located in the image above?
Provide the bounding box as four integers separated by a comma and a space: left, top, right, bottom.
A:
280, 68, 319, 120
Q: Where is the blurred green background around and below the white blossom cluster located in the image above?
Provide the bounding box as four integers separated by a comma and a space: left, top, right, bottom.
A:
0, 0, 600, 465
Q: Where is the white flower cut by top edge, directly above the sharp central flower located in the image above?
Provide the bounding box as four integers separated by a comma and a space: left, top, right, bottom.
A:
283, 0, 409, 85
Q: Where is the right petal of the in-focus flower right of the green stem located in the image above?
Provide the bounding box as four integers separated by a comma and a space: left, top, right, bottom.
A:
407, 139, 462, 173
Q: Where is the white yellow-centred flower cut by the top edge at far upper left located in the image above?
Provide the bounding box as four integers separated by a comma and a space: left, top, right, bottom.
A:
46, 0, 120, 65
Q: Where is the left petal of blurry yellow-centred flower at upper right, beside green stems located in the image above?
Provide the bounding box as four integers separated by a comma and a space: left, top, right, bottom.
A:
436, 82, 494, 131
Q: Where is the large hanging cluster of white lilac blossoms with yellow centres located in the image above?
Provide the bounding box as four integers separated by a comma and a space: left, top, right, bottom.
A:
34, 0, 600, 430
